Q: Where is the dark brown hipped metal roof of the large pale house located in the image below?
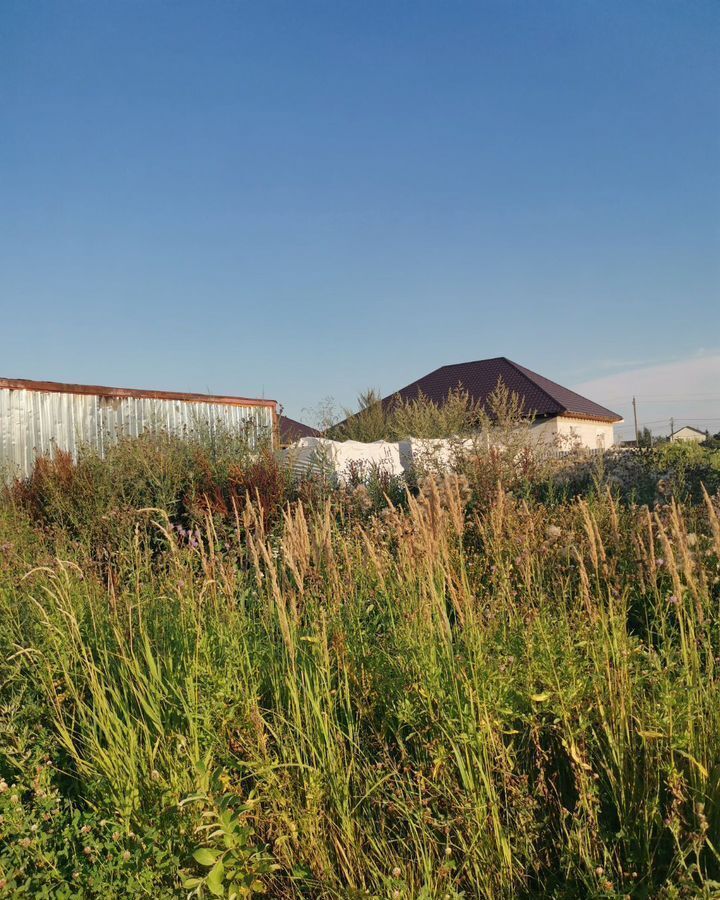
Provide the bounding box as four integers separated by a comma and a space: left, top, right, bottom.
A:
383, 356, 622, 422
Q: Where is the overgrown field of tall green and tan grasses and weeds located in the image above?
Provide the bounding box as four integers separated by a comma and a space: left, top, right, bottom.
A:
0, 441, 720, 900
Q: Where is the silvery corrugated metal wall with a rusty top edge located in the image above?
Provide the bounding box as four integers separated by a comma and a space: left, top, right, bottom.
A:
0, 379, 277, 476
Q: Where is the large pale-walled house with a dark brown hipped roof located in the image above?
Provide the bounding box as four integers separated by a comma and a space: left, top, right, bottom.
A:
374, 356, 623, 450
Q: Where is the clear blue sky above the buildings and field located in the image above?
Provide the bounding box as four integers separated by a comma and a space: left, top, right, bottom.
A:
0, 0, 720, 431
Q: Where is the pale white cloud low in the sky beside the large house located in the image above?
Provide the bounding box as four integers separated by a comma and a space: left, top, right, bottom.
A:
574, 352, 720, 438
